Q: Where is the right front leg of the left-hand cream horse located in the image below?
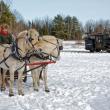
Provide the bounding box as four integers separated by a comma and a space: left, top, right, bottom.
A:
18, 68, 24, 96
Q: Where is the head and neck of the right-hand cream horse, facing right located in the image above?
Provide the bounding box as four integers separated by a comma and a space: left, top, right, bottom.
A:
36, 35, 63, 60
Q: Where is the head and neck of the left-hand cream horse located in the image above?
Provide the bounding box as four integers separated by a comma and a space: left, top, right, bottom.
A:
17, 29, 39, 56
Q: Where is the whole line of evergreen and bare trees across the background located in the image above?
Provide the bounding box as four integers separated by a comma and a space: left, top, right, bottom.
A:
0, 1, 110, 40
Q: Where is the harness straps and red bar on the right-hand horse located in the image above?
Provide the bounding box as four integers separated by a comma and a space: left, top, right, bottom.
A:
25, 39, 62, 73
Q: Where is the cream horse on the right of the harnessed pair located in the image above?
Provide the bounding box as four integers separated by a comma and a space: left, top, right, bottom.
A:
30, 35, 63, 92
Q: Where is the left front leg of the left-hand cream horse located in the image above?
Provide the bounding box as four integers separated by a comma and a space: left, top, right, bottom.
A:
9, 69, 14, 96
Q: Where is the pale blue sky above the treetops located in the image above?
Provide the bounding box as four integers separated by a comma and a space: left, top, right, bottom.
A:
12, 0, 110, 24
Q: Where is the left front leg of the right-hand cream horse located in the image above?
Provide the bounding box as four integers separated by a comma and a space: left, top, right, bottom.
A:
31, 69, 38, 91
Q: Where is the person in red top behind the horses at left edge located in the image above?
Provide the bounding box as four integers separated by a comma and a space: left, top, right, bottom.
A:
0, 24, 12, 44
